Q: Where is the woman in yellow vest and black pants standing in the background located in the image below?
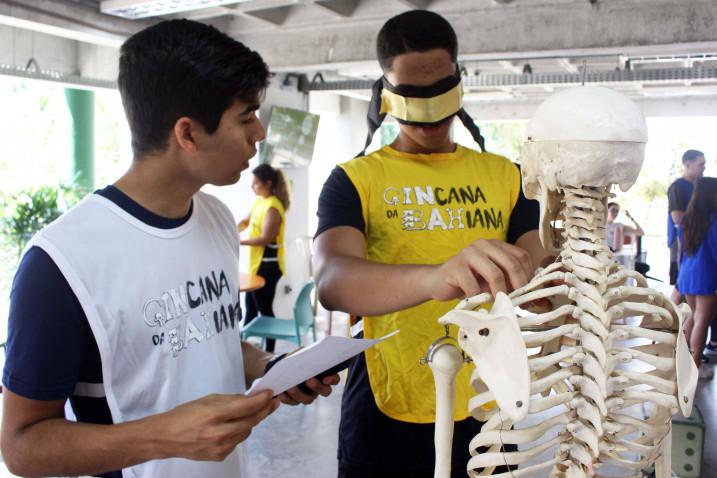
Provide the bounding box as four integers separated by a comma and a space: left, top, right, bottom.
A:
238, 164, 290, 352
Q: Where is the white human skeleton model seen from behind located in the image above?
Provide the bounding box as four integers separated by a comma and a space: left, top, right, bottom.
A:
426, 86, 697, 478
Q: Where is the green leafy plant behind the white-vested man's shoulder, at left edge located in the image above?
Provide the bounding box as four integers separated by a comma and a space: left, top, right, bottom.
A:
0, 184, 78, 254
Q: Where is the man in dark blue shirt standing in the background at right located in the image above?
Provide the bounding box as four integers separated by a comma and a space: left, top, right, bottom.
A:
667, 149, 705, 296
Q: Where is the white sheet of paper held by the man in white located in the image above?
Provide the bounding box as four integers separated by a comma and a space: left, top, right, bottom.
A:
247, 330, 398, 395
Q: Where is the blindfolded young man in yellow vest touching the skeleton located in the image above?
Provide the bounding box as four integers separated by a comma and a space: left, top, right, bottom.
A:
316, 10, 546, 478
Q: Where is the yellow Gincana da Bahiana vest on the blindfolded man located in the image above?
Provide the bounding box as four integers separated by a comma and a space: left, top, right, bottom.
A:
340, 145, 520, 423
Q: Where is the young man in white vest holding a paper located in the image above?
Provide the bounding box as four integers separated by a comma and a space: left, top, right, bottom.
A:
2, 20, 338, 478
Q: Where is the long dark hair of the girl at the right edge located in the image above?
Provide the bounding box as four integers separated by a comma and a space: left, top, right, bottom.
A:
680, 178, 717, 256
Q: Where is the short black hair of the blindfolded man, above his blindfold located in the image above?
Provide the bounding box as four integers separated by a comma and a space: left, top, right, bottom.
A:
376, 10, 458, 71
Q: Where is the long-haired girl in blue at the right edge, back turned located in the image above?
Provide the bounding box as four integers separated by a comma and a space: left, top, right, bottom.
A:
677, 178, 717, 378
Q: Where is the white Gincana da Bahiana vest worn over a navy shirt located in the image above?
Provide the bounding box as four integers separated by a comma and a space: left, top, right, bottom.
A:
32, 192, 245, 478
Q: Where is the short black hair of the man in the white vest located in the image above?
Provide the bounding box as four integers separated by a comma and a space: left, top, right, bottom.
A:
117, 20, 270, 157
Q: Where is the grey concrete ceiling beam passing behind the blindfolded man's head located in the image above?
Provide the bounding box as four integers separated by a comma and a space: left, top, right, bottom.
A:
238, 0, 717, 70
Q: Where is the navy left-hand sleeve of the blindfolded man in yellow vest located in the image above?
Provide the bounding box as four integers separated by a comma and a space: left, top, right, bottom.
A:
314, 166, 366, 237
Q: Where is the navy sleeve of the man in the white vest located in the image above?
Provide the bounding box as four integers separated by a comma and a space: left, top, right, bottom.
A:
3, 247, 96, 400
